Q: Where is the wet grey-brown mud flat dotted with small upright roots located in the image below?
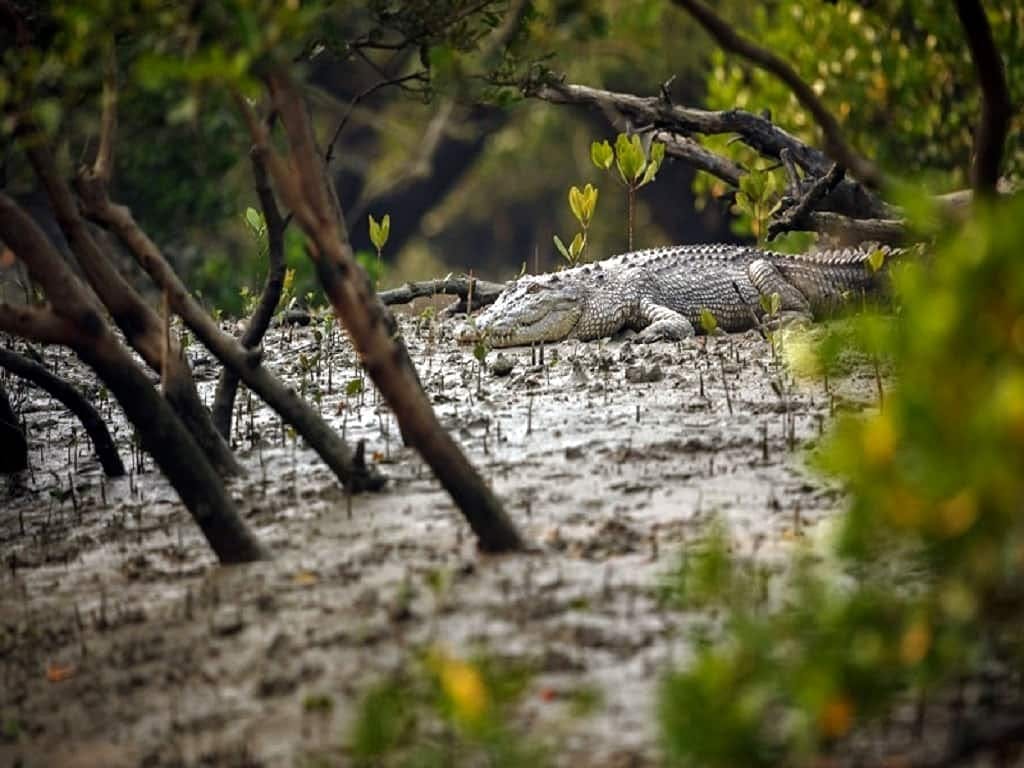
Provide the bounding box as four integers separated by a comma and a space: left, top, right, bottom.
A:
0, 314, 892, 766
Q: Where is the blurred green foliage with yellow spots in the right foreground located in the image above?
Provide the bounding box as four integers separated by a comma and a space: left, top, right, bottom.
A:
660, 200, 1024, 766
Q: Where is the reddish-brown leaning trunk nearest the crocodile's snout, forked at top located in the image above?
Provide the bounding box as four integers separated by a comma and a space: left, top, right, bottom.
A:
260, 70, 522, 552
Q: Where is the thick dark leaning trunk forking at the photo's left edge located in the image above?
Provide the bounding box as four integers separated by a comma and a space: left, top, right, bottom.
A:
0, 193, 267, 562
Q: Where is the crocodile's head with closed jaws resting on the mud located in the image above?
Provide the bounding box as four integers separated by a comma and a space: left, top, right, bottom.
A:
462, 274, 585, 347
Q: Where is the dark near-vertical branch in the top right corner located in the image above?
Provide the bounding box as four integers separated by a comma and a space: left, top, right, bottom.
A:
956, 0, 1012, 196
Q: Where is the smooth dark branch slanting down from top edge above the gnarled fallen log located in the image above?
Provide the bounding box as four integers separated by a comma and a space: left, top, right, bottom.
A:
672, 0, 884, 187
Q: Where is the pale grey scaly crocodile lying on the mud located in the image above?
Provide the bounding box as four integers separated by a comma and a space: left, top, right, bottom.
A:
461, 245, 898, 347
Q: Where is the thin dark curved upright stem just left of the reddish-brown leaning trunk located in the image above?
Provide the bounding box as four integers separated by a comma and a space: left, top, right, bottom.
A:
211, 148, 288, 440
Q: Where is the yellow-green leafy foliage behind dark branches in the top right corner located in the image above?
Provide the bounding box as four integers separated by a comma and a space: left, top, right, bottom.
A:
696, 0, 1024, 231
